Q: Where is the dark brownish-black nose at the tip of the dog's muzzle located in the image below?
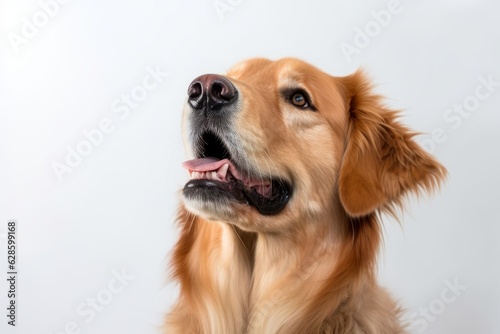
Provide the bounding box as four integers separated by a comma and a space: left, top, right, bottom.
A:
188, 74, 238, 110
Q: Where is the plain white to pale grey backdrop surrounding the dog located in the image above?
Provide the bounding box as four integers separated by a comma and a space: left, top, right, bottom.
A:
0, 0, 500, 334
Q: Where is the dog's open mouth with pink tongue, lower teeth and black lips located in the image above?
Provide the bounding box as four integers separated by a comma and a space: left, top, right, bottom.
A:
183, 132, 292, 215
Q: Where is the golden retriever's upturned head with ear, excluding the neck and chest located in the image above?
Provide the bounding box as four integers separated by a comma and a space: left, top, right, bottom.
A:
183, 59, 445, 233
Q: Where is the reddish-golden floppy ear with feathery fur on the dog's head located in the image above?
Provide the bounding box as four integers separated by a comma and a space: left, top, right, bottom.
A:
338, 71, 446, 217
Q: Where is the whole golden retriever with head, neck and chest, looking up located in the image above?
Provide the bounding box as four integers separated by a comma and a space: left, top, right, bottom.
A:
164, 58, 446, 334
